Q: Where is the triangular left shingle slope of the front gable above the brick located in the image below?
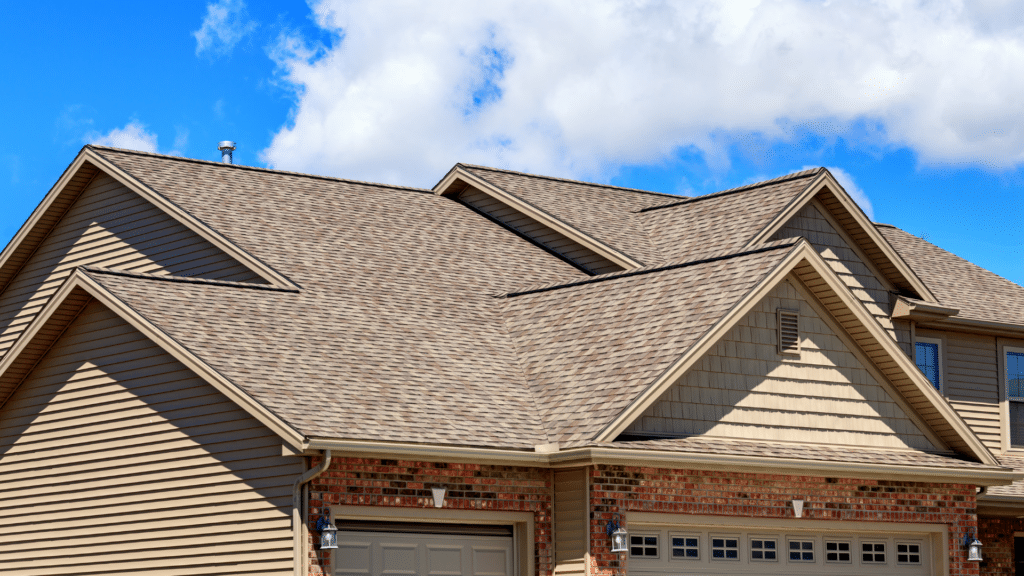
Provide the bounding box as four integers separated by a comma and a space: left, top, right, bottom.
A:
504, 243, 794, 445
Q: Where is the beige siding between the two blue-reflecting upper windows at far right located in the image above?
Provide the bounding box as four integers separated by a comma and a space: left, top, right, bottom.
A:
916, 328, 1002, 451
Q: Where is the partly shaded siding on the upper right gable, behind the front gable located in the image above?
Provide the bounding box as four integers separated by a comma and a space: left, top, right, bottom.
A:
772, 202, 898, 339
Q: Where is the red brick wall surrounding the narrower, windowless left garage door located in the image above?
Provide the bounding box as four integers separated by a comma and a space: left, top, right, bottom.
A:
307, 458, 552, 576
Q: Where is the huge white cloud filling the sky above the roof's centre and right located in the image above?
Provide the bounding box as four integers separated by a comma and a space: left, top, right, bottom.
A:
263, 0, 1024, 183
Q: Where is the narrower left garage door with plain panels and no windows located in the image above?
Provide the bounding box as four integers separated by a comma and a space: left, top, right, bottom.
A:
334, 523, 515, 576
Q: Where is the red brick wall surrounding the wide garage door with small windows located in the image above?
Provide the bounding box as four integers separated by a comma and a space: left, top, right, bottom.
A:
590, 465, 978, 576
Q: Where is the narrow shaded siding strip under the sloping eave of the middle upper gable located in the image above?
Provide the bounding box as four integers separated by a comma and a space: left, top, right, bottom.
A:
459, 188, 623, 274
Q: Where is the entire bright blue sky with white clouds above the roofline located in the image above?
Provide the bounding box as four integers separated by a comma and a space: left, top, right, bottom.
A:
0, 0, 1024, 285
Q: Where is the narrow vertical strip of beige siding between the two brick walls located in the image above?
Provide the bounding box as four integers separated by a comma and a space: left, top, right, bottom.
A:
554, 469, 590, 574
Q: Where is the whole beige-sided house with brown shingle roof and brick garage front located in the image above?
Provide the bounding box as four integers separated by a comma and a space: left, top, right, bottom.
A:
0, 146, 1024, 576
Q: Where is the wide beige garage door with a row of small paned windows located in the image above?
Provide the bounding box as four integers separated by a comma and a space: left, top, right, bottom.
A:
628, 526, 933, 576
